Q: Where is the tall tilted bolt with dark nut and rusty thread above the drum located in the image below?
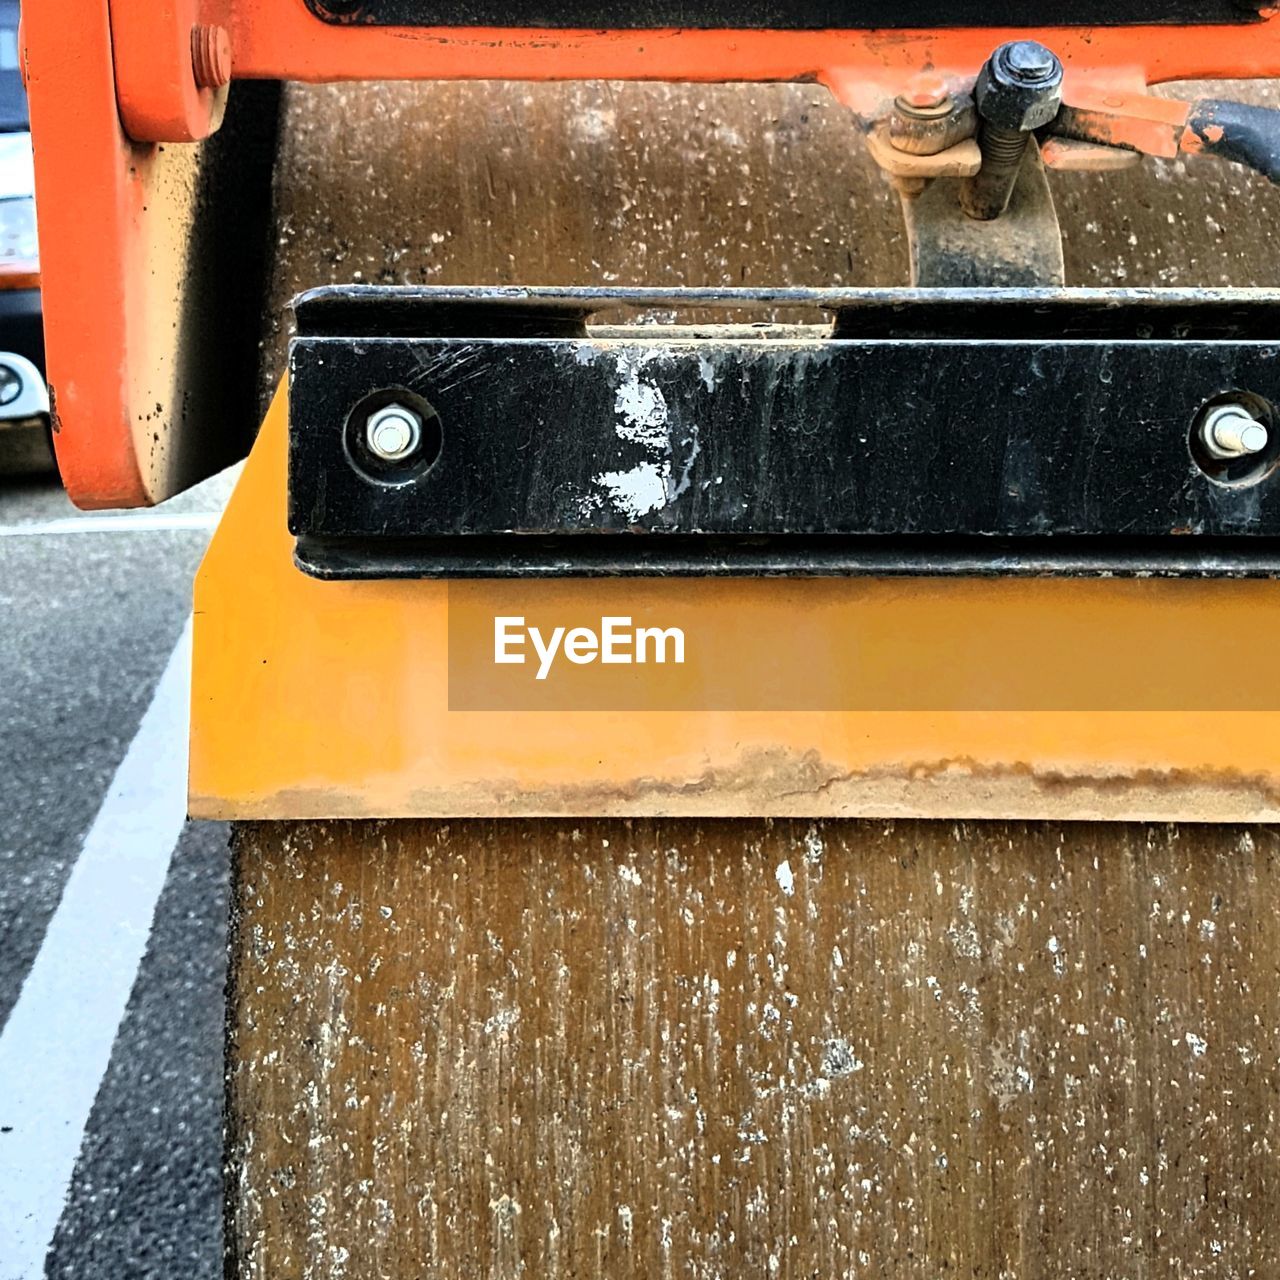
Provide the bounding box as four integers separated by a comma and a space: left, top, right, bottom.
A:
960, 40, 1062, 221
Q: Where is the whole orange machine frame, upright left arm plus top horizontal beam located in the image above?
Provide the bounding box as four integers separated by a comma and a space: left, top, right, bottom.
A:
23, 0, 1280, 507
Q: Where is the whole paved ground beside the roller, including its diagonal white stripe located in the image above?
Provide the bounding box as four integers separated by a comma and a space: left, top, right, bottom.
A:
0, 442, 238, 1280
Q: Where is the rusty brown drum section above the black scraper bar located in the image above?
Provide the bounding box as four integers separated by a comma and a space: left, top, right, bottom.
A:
264, 74, 1280, 384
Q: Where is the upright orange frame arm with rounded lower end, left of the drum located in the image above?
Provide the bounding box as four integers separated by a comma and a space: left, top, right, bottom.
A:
22, 0, 241, 508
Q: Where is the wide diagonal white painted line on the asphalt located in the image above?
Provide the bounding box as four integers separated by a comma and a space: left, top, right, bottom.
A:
0, 620, 191, 1280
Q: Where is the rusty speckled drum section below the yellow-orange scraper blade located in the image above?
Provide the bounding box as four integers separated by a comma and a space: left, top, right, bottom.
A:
230, 822, 1280, 1280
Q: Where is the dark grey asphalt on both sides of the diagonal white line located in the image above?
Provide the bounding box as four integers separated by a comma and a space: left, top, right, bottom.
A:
0, 450, 238, 1280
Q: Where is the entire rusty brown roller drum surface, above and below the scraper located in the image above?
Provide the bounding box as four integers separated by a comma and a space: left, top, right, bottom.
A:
228, 74, 1280, 1280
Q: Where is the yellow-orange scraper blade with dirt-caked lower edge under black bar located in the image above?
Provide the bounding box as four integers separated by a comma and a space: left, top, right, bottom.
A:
191, 390, 1280, 820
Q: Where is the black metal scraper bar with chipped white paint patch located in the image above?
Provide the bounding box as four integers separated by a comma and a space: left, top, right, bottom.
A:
289, 288, 1280, 577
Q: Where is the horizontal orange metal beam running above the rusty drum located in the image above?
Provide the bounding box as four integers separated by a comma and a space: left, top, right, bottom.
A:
154, 0, 1280, 136
